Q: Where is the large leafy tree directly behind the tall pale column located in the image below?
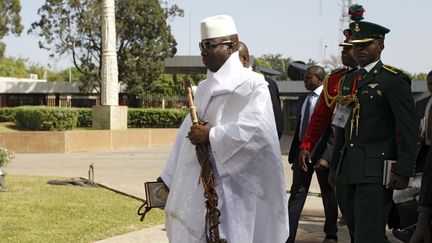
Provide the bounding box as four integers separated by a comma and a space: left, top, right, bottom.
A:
29, 0, 183, 95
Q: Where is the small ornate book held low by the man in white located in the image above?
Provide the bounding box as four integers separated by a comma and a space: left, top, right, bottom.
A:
144, 181, 168, 208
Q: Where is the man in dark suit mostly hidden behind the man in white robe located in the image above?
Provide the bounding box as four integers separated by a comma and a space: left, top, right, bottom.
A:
239, 41, 284, 139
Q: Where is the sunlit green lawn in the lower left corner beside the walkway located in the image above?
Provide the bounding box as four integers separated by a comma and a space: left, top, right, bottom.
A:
0, 175, 164, 243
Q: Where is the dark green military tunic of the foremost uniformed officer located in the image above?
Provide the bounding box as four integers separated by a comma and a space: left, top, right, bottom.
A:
333, 62, 419, 184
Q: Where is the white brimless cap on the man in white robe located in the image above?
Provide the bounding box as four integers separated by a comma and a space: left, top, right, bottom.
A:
201, 15, 237, 40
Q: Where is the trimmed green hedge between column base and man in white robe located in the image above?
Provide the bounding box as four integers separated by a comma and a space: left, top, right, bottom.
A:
128, 108, 188, 128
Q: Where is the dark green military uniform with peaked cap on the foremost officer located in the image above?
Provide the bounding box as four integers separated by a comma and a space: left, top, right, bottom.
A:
332, 18, 418, 243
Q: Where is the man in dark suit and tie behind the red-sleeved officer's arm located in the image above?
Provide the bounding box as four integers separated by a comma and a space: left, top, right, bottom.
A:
287, 66, 338, 243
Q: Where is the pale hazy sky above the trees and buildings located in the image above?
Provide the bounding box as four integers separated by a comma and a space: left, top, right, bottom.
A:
3, 0, 432, 73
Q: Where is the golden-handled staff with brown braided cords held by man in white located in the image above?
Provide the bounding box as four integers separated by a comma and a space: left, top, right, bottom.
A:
187, 81, 227, 243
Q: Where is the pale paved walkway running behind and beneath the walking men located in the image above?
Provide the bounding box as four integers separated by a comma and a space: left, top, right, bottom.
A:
7, 137, 399, 243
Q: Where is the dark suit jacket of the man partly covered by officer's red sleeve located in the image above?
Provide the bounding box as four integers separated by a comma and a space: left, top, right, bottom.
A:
288, 94, 331, 163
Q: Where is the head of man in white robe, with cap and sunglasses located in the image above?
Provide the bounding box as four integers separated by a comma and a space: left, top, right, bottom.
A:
199, 15, 238, 72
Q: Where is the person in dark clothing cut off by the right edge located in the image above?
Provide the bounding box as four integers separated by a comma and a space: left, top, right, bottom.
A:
416, 71, 432, 172
